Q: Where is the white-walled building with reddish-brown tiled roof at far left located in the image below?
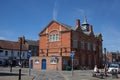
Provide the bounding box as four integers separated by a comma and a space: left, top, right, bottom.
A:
0, 40, 28, 66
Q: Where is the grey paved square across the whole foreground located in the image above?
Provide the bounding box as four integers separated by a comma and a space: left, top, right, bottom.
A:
0, 67, 120, 80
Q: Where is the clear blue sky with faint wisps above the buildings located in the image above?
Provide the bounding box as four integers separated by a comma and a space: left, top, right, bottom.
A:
0, 0, 120, 52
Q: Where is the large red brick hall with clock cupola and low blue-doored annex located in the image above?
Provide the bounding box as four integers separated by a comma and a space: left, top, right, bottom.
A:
31, 18, 102, 70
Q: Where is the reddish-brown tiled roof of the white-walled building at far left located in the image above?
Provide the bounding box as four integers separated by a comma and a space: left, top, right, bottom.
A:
0, 40, 27, 50
